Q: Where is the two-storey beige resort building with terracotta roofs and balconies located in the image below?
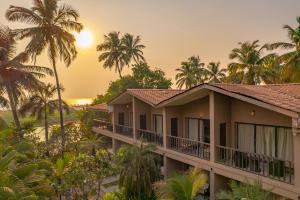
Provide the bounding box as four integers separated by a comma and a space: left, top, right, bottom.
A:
93, 84, 300, 199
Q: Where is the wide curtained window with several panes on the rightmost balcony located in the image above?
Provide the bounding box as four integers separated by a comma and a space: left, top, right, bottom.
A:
236, 123, 293, 161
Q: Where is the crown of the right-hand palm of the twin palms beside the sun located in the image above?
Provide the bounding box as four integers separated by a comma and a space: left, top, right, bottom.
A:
122, 33, 145, 64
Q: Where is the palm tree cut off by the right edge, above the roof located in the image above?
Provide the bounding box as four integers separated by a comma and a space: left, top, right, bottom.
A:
269, 17, 300, 82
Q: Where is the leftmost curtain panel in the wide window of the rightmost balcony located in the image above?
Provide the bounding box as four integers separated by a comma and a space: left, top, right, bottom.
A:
238, 124, 254, 153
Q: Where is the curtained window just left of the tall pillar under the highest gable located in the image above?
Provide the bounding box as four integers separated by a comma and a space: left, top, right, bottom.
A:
187, 118, 210, 143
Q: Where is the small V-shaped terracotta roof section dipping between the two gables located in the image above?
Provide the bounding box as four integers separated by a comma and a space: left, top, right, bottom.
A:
127, 89, 185, 105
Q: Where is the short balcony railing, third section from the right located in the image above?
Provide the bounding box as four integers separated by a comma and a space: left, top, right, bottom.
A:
136, 129, 163, 146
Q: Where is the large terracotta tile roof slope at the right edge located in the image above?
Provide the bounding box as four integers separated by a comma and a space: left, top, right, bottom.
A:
209, 84, 300, 113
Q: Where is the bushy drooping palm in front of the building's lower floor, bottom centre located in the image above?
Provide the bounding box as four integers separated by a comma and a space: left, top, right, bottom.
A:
119, 144, 160, 199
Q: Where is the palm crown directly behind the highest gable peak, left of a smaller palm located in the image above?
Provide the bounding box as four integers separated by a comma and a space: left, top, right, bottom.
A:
175, 56, 206, 89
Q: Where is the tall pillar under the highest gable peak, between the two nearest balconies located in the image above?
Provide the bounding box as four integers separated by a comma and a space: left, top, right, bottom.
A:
209, 91, 215, 162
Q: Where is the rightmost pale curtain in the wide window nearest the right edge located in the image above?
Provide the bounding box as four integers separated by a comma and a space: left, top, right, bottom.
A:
277, 128, 293, 161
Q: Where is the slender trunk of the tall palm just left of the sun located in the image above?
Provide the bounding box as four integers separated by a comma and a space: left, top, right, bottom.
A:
53, 61, 66, 155
